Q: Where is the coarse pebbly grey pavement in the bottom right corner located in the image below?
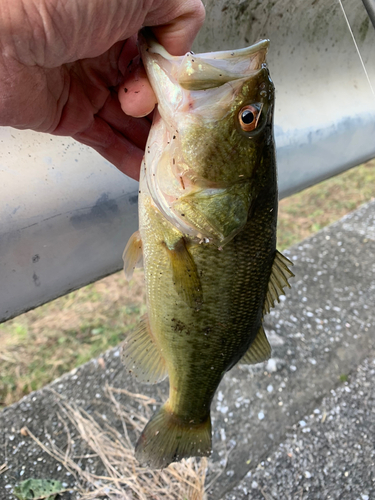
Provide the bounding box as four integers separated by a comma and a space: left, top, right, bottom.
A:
224, 357, 375, 500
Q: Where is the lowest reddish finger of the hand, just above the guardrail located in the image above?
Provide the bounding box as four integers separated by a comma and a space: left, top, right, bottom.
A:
73, 116, 143, 180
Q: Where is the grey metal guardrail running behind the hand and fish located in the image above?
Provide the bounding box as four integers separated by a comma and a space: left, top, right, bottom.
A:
0, 0, 375, 321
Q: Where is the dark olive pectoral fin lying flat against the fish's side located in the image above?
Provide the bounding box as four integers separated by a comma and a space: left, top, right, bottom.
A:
165, 238, 202, 309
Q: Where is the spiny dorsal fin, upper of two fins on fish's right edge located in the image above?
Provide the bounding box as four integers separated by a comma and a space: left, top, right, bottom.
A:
263, 250, 294, 314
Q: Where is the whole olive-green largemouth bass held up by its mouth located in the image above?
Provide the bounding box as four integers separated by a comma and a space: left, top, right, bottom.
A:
123, 32, 293, 468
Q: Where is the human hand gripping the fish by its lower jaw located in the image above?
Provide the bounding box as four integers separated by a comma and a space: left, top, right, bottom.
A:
0, 0, 204, 179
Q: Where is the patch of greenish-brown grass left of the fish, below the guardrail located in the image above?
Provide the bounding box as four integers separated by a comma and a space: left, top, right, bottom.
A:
0, 273, 145, 406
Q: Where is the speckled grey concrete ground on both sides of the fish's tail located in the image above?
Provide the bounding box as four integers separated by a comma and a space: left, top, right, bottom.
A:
0, 198, 375, 500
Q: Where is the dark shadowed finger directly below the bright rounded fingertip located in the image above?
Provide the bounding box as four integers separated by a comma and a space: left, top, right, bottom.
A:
96, 93, 150, 150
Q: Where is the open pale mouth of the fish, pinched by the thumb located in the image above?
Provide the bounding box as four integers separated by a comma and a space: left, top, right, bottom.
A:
139, 28, 270, 92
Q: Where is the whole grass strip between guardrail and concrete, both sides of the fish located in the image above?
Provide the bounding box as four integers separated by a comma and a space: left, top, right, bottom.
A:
0, 161, 375, 406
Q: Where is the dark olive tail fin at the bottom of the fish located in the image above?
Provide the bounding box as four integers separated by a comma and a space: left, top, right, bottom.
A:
135, 404, 211, 469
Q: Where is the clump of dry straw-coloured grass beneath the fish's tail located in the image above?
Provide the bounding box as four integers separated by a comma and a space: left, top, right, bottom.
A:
25, 386, 207, 500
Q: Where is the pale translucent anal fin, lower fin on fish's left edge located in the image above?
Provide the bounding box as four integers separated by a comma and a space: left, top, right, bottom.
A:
122, 314, 168, 384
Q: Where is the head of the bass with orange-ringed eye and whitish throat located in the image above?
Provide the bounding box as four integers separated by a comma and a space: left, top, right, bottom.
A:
140, 33, 274, 245
